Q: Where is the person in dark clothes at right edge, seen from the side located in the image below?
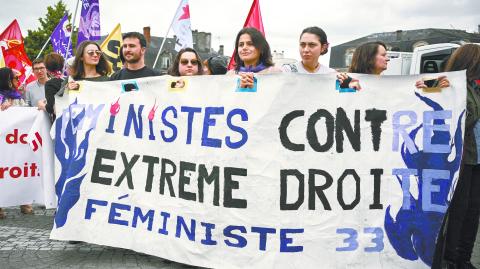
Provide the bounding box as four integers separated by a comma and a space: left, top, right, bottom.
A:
437, 44, 480, 269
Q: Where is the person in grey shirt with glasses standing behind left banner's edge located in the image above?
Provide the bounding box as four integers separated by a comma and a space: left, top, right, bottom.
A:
25, 59, 48, 110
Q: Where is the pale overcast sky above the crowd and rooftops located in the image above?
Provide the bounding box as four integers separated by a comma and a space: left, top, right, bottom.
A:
0, 0, 480, 65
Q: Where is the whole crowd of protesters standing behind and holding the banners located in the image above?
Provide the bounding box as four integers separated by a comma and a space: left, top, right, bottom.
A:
0, 27, 480, 269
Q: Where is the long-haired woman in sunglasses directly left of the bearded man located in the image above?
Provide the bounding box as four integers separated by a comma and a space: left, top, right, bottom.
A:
65, 41, 112, 90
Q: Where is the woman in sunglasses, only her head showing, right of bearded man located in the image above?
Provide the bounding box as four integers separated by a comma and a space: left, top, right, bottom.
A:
168, 48, 203, 77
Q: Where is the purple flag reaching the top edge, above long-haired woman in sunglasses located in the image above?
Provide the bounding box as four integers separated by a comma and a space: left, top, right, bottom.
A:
77, 0, 100, 46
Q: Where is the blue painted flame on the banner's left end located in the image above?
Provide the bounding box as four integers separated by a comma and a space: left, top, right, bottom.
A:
55, 99, 104, 228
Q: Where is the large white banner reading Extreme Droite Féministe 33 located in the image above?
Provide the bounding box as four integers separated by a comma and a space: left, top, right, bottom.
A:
51, 72, 466, 269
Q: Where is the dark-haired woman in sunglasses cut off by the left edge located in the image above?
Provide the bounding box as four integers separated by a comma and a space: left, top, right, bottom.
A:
0, 67, 25, 111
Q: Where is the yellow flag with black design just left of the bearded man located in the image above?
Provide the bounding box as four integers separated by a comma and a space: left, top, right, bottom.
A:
100, 23, 123, 72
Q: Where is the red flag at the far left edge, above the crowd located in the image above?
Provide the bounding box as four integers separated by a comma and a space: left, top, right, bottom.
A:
0, 20, 35, 84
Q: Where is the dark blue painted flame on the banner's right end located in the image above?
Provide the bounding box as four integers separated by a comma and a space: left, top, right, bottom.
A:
385, 93, 465, 266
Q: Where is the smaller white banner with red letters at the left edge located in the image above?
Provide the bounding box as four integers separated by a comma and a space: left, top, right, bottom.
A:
0, 107, 57, 208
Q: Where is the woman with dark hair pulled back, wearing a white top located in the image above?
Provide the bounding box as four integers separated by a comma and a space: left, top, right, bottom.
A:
282, 26, 336, 74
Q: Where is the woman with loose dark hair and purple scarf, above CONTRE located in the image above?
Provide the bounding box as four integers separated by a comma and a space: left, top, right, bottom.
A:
227, 28, 282, 88
